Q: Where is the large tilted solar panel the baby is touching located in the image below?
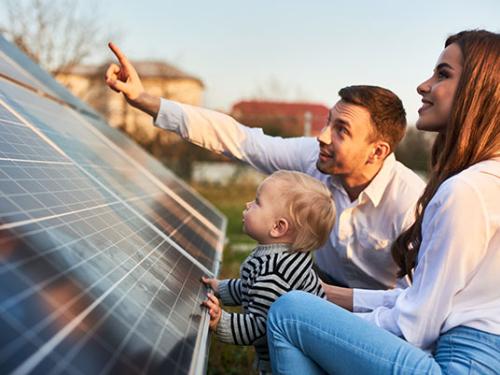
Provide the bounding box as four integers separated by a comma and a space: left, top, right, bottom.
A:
0, 37, 226, 375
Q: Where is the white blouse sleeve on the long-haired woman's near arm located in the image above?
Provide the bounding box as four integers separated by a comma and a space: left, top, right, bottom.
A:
359, 178, 488, 349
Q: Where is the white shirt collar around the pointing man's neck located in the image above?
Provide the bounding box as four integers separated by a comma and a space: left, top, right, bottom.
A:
330, 153, 396, 207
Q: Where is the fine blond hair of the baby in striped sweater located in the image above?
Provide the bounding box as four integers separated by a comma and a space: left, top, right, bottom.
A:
268, 171, 335, 251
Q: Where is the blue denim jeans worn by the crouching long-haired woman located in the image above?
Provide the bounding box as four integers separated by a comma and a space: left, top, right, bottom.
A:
267, 291, 500, 375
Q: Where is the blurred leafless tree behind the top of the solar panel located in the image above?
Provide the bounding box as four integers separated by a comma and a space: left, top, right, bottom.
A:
0, 0, 115, 75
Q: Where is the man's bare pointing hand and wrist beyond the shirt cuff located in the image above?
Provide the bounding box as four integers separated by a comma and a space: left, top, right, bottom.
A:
105, 42, 160, 118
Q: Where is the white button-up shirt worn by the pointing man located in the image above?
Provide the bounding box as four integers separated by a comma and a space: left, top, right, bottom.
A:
155, 99, 425, 289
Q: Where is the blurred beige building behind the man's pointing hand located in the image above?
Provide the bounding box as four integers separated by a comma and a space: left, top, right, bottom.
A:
56, 61, 205, 145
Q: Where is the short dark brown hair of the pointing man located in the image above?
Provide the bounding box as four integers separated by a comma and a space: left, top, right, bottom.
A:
339, 86, 406, 151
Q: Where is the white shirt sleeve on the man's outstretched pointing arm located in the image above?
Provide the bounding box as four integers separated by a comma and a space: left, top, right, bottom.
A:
155, 99, 318, 174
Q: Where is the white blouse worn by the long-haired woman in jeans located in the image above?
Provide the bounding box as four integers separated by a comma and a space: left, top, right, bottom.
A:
354, 158, 500, 350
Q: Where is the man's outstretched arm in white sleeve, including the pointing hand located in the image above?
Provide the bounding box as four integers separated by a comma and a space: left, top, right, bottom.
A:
105, 43, 318, 173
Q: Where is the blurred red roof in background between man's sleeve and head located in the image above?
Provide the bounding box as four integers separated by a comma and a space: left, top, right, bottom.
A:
231, 100, 329, 137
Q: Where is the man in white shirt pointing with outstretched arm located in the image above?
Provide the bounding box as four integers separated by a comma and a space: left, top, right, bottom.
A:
106, 43, 425, 302
